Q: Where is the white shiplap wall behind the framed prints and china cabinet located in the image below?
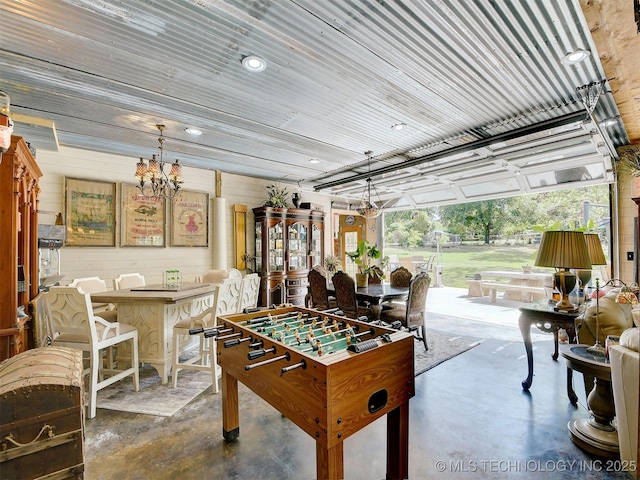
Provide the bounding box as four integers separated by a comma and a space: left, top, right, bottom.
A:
37, 147, 331, 288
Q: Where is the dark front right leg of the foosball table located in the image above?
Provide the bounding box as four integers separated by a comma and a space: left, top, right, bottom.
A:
387, 401, 409, 480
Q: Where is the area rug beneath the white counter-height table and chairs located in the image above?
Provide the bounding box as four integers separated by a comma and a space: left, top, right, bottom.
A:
98, 365, 211, 417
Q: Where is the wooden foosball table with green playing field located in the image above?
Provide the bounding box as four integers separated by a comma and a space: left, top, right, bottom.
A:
210, 306, 415, 480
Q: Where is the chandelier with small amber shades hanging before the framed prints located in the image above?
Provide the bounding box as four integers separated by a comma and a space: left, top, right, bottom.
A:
135, 125, 184, 200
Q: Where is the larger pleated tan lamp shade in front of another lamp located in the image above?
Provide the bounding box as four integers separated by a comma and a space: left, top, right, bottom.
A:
535, 230, 592, 270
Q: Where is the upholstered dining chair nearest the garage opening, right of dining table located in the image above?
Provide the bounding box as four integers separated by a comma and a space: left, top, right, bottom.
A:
380, 273, 431, 350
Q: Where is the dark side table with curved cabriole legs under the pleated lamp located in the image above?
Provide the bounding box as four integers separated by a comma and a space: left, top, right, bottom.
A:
518, 299, 579, 390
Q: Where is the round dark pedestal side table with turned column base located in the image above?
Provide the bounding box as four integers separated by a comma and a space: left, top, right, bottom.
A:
561, 345, 620, 458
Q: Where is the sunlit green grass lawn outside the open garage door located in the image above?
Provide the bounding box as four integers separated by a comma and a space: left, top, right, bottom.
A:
384, 245, 553, 288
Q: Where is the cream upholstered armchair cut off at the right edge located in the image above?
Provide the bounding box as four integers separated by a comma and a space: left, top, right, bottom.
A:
609, 327, 640, 478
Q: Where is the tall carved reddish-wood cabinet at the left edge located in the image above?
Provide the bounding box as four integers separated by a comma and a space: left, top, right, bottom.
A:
0, 136, 42, 360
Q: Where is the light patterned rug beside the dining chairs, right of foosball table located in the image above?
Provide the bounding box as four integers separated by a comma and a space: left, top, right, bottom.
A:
416, 329, 480, 376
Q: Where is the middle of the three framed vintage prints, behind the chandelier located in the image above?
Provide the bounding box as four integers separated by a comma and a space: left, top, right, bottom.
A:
121, 183, 166, 247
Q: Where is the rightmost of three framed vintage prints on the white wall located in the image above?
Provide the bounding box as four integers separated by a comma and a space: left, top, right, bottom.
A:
171, 190, 209, 247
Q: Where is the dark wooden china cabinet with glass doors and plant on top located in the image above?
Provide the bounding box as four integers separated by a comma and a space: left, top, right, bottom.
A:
253, 207, 324, 306
